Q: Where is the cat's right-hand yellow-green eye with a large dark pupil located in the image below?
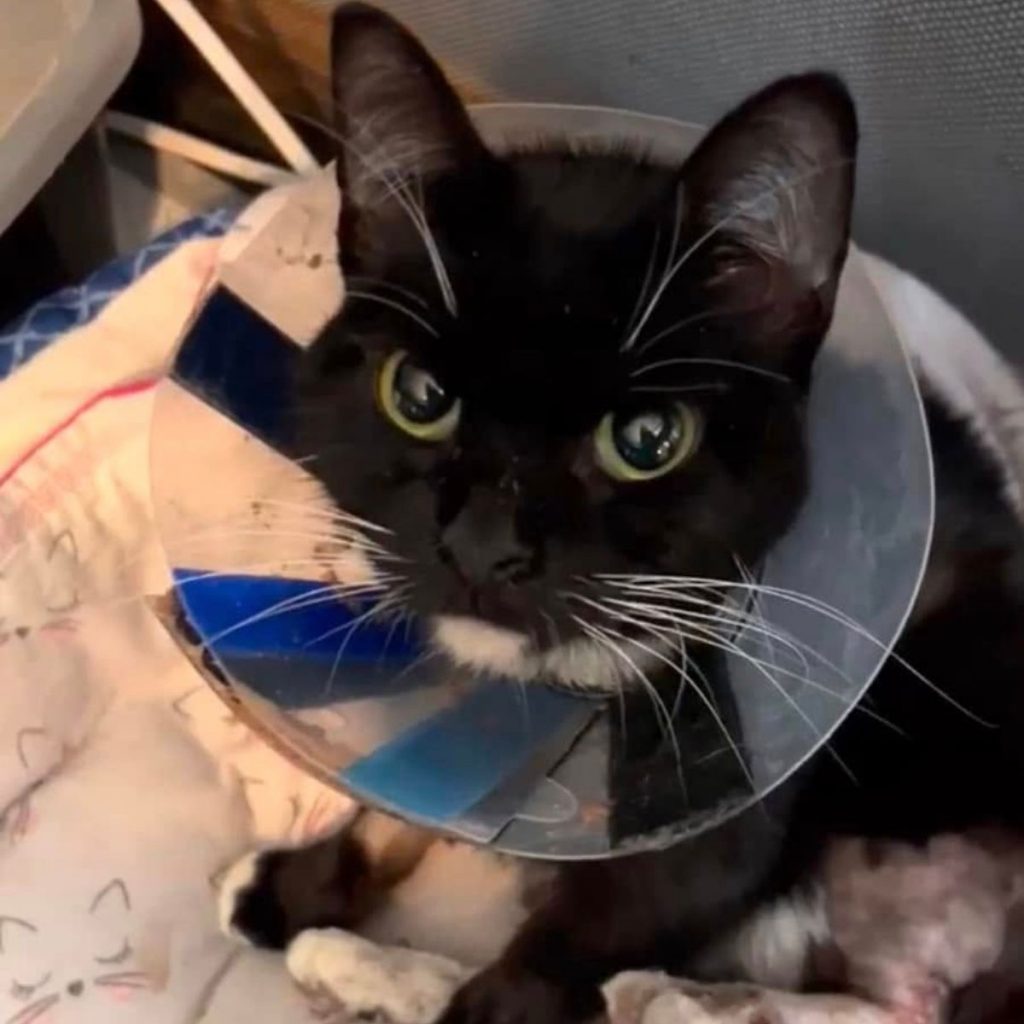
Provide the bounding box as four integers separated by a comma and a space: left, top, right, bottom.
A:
594, 402, 702, 482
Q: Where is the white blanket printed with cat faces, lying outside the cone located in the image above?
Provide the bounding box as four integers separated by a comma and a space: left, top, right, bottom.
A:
0, 172, 1024, 1024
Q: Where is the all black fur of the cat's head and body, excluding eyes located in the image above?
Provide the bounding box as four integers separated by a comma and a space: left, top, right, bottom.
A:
247, 5, 1024, 1024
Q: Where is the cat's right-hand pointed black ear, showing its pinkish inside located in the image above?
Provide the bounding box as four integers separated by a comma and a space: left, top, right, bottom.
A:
683, 74, 857, 371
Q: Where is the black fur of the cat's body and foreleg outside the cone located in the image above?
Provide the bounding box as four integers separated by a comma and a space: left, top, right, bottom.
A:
434, 391, 1024, 1024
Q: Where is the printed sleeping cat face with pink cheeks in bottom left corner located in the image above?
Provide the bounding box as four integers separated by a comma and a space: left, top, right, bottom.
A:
0, 879, 154, 1024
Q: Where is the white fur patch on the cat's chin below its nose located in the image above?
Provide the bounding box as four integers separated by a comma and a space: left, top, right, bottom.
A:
434, 615, 656, 693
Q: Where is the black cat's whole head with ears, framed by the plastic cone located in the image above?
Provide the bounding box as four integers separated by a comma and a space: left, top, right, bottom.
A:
299, 5, 857, 687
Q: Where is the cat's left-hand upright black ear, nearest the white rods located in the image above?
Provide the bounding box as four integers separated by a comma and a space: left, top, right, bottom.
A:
331, 3, 485, 262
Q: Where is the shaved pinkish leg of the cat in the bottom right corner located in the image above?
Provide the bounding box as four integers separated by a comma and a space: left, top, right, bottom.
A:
603, 835, 1024, 1024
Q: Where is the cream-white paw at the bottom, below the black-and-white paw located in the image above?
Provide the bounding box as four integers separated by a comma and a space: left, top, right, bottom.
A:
287, 929, 467, 1024
